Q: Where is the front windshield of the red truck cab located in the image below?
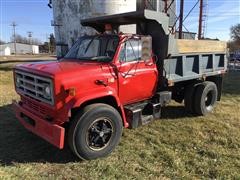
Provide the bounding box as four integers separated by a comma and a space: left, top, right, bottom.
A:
64, 35, 119, 62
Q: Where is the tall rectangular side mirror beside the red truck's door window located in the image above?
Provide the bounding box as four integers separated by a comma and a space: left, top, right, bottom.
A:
141, 36, 152, 61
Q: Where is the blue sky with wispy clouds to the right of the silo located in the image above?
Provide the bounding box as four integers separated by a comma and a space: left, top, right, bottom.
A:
181, 0, 240, 40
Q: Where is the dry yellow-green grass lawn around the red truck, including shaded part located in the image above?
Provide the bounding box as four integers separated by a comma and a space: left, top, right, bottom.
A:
0, 58, 240, 179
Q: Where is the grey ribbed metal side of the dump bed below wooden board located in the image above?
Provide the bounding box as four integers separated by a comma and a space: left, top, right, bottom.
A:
164, 53, 227, 83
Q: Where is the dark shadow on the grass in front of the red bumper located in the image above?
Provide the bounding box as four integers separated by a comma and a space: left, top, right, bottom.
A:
0, 105, 78, 165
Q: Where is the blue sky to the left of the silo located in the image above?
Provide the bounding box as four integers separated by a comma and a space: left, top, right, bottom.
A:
0, 0, 53, 41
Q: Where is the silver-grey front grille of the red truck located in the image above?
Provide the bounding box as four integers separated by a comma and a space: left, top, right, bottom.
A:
15, 71, 54, 105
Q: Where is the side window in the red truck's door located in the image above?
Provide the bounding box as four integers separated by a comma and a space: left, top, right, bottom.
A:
119, 39, 142, 62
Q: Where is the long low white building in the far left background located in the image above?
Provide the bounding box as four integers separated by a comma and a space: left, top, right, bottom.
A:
0, 43, 39, 56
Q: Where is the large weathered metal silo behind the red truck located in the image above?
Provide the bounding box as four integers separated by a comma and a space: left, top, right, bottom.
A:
49, 0, 176, 56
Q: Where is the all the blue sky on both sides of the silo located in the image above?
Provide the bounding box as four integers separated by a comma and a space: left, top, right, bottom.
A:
0, 0, 240, 41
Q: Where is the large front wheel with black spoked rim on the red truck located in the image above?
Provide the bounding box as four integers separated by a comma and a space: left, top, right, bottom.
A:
68, 104, 123, 160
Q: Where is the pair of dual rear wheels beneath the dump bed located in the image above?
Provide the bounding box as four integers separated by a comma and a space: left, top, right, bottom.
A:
184, 81, 218, 116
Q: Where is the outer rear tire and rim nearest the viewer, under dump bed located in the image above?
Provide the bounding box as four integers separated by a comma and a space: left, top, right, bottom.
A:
194, 81, 218, 116
